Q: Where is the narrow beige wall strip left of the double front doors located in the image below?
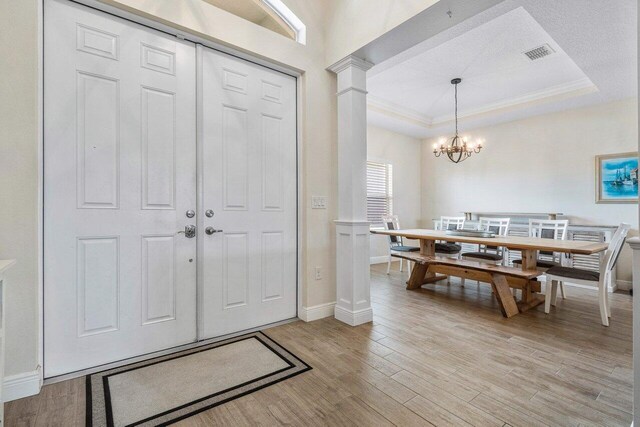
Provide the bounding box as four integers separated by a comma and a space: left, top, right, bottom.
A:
0, 0, 38, 375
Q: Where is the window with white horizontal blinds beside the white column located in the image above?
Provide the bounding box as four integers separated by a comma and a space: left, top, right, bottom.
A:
367, 162, 393, 226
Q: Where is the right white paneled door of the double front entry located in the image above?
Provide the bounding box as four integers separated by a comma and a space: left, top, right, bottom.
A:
198, 47, 297, 338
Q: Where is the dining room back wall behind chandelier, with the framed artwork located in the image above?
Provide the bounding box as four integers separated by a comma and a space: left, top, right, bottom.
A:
422, 99, 638, 281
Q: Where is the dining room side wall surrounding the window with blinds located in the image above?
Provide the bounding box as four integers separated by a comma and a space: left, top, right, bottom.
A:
367, 126, 421, 262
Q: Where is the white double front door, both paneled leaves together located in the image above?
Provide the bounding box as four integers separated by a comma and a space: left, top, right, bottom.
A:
44, 0, 297, 377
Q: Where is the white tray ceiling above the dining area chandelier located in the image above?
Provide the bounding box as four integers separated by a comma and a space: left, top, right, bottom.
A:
367, 0, 637, 137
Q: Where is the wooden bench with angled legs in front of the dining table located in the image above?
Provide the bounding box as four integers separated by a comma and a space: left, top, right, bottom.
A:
394, 252, 544, 317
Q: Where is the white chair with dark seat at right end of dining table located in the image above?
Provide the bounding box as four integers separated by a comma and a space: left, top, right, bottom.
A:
544, 223, 631, 326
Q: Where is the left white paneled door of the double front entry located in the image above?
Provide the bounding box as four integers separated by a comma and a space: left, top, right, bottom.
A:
44, 0, 196, 377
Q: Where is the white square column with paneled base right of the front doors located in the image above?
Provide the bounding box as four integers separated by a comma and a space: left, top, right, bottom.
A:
329, 56, 373, 326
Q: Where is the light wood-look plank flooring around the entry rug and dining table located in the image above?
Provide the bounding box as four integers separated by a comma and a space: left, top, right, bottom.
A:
5, 263, 632, 427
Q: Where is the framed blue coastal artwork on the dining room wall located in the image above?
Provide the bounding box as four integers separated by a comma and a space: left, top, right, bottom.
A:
596, 152, 638, 203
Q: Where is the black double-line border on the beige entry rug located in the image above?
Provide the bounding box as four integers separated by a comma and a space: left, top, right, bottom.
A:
85, 331, 313, 427
